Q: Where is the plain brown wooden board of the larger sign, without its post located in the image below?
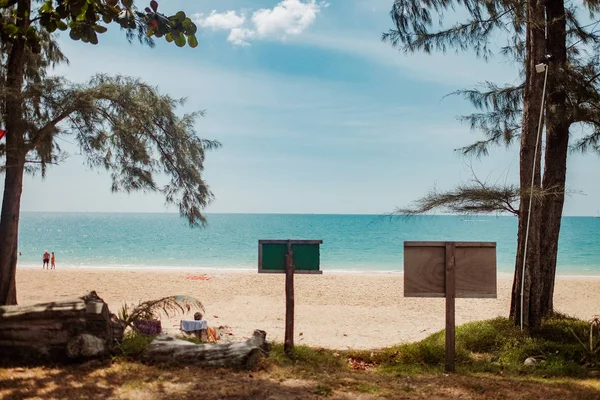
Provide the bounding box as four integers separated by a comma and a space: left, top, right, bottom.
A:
404, 242, 497, 298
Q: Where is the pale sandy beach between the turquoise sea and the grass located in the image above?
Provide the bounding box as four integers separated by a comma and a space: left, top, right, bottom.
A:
12, 268, 600, 349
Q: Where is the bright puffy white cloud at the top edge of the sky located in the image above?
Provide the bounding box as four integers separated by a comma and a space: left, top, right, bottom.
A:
194, 0, 328, 45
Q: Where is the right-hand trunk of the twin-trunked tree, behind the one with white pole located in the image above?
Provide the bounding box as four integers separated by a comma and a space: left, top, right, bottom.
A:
540, 0, 570, 315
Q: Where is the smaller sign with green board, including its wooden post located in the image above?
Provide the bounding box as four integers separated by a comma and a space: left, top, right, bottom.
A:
258, 240, 323, 355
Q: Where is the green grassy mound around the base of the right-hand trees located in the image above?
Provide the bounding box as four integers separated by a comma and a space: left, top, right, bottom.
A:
268, 315, 600, 378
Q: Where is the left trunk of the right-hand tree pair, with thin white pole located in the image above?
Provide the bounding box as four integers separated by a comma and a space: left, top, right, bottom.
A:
510, 0, 545, 328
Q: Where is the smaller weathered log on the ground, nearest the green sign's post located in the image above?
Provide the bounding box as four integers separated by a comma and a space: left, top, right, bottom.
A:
142, 330, 270, 369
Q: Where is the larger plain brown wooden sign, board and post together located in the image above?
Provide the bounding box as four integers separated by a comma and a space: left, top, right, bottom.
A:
404, 242, 497, 372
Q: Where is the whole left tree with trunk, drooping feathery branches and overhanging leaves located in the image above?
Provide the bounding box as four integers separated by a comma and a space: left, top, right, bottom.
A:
0, 0, 219, 305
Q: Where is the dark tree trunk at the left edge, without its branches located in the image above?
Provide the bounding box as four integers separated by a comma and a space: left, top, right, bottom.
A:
0, 0, 31, 305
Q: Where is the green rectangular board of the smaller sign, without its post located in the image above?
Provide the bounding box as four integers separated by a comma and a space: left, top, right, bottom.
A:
258, 240, 323, 274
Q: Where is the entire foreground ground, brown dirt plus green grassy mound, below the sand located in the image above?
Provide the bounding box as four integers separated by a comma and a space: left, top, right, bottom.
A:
0, 315, 600, 399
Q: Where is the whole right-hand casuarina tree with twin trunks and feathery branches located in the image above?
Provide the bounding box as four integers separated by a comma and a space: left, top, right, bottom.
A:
383, 0, 600, 328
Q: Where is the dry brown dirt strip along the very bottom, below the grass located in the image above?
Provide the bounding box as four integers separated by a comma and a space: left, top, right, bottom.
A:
0, 361, 600, 400
